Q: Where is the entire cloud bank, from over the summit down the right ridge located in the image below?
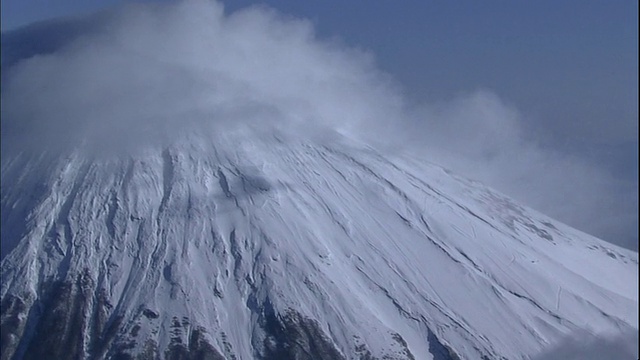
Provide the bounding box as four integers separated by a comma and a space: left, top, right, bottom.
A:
2, 0, 637, 248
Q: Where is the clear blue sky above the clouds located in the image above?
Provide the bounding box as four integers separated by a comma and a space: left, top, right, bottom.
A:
2, 0, 638, 249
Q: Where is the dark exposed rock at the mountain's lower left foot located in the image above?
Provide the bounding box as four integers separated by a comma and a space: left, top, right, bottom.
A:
0, 273, 235, 360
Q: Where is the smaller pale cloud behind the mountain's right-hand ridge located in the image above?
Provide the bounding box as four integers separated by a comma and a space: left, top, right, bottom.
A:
402, 91, 638, 250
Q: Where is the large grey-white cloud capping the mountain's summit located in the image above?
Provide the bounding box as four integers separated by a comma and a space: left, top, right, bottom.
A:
3, 1, 401, 155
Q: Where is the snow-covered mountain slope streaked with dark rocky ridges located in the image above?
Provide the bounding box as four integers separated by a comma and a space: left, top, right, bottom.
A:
1, 130, 638, 360
